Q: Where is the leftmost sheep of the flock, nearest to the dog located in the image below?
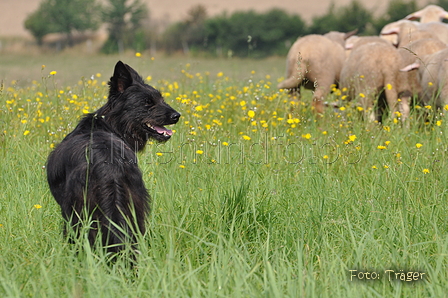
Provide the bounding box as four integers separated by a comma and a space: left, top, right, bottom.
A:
277, 31, 356, 114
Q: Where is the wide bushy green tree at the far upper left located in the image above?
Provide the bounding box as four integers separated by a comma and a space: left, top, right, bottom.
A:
25, 0, 100, 46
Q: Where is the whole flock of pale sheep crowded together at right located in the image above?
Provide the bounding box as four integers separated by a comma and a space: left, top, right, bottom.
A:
278, 5, 448, 121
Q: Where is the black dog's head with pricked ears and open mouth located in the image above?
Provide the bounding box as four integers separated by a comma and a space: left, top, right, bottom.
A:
105, 61, 180, 150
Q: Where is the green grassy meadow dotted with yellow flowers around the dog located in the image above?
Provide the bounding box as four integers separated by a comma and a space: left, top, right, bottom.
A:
0, 54, 448, 298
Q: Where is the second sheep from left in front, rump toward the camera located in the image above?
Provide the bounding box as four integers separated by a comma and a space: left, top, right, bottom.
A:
340, 42, 410, 122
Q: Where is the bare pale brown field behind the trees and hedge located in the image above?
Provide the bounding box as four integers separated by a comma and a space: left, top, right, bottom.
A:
0, 0, 427, 37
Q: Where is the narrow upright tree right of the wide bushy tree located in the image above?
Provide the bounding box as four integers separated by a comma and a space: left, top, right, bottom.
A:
102, 0, 148, 54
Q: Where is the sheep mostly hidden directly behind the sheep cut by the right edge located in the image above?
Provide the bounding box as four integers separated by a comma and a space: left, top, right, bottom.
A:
398, 38, 446, 95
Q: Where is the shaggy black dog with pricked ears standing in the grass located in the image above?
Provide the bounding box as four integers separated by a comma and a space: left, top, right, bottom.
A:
47, 61, 180, 252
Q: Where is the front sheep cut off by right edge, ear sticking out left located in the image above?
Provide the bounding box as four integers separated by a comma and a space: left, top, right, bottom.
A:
401, 48, 448, 108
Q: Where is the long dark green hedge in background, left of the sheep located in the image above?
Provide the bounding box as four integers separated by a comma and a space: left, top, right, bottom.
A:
164, 9, 306, 57
